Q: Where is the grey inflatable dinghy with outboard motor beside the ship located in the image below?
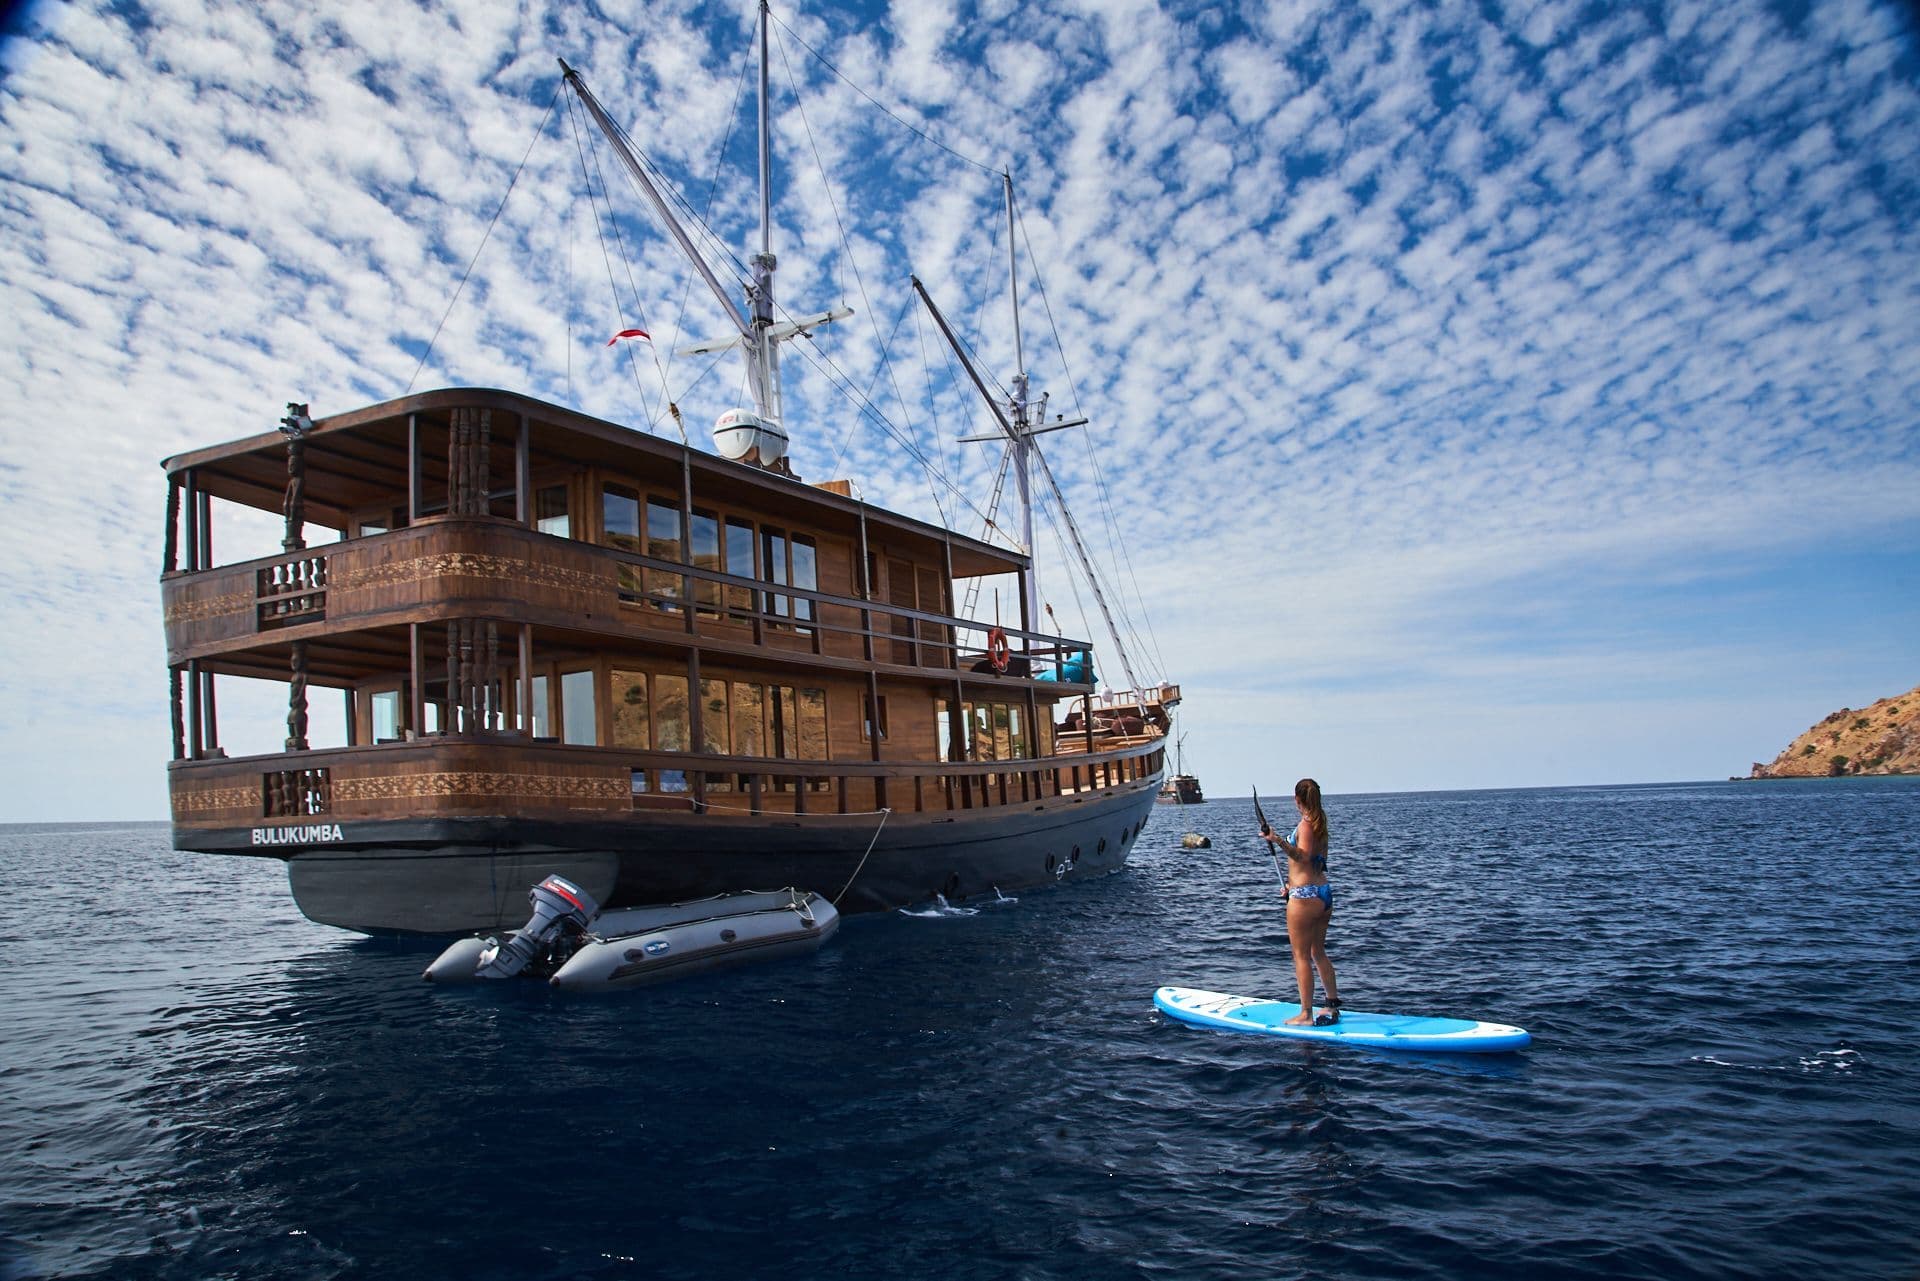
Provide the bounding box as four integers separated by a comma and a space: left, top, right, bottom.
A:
422, 876, 839, 991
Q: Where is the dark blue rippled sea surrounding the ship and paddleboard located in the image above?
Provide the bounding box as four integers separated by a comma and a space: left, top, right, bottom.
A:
0, 780, 1920, 1281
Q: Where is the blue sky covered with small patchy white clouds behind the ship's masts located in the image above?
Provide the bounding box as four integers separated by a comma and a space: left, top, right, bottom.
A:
0, 0, 1920, 820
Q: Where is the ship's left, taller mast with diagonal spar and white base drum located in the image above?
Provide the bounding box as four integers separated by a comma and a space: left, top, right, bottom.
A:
561, 0, 852, 467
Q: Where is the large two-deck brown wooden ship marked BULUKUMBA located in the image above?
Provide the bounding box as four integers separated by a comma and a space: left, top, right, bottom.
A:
161, 10, 1179, 933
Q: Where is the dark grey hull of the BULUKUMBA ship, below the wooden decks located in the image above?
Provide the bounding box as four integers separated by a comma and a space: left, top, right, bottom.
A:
175, 776, 1160, 935
